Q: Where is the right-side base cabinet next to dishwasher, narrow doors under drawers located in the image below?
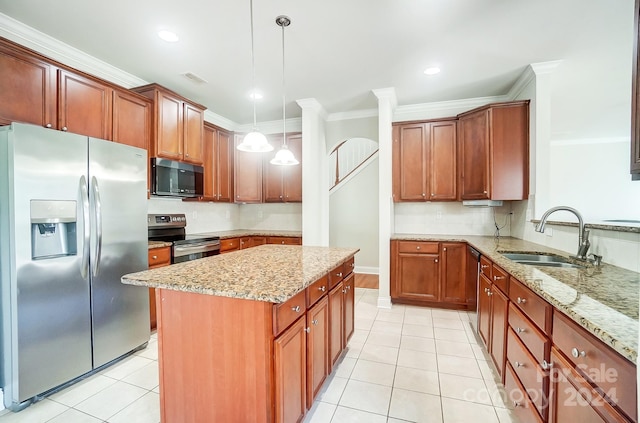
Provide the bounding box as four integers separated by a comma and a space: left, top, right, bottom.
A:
478, 256, 509, 381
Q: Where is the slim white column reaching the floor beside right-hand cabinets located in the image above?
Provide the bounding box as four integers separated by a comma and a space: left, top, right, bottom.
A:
373, 88, 397, 308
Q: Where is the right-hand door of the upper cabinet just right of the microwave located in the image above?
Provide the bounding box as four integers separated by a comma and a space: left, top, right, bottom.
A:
213, 129, 234, 203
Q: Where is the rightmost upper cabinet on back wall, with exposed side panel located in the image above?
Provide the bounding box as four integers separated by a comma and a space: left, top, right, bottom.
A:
458, 100, 529, 200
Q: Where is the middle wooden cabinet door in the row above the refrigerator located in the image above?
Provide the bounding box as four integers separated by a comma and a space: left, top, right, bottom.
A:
58, 69, 113, 140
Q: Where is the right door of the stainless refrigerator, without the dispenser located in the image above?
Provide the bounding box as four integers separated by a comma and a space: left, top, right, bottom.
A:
89, 138, 150, 367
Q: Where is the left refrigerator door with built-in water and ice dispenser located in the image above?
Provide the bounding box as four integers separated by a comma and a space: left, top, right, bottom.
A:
0, 124, 91, 407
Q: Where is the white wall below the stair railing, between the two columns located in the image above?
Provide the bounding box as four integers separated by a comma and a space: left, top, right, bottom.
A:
329, 159, 379, 274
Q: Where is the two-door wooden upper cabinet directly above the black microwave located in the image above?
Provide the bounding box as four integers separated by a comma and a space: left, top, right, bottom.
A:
133, 84, 205, 165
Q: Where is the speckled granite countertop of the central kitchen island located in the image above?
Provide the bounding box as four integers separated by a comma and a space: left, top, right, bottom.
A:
122, 245, 360, 303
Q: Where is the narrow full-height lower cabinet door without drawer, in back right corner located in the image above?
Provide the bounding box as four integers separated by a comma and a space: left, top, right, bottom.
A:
440, 242, 468, 304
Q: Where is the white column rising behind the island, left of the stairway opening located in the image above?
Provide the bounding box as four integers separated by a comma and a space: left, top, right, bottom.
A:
297, 98, 329, 247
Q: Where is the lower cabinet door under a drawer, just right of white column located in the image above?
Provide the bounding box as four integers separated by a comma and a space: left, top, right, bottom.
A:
397, 253, 440, 302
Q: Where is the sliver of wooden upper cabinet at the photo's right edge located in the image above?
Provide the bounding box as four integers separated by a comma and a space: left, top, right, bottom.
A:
631, 0, 640, 181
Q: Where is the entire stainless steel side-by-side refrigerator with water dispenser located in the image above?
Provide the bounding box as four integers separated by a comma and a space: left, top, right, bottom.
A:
0, 123, 150, 410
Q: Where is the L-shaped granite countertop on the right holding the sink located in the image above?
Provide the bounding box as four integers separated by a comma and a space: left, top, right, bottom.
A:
392, 234, 640, 363
